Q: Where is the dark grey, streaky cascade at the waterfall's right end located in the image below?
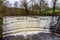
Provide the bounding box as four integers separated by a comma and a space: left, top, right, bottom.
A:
50, 16, 60, 34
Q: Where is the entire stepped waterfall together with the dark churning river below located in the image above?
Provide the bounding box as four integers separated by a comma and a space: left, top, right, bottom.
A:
3, 16, 60, 40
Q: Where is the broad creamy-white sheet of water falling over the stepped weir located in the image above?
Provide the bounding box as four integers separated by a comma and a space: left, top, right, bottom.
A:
3, 16, 51, 37
